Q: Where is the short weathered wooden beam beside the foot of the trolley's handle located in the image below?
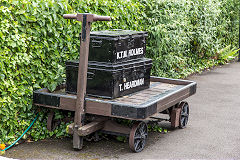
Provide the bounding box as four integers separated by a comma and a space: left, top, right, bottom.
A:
78, 121, 104, 136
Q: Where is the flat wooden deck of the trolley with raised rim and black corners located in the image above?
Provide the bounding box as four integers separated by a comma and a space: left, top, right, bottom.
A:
34, 77, 196, 120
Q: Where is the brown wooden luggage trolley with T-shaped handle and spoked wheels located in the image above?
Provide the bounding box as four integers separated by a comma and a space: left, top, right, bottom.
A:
33, 14, 196, 152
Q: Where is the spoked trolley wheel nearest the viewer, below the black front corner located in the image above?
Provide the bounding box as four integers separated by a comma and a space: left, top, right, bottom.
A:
129, 122, 148, 152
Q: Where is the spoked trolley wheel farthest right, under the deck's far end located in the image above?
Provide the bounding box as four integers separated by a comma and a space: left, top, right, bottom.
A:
179, 102, 189, 129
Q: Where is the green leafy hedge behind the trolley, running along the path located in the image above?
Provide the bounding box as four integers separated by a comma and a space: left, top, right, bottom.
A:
0, 0, 239, 143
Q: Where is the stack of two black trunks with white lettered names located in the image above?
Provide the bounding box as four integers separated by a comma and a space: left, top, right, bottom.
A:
66, 30, 152, 99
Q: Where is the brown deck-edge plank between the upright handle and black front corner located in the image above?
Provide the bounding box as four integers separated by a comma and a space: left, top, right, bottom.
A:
85, 101, 112, 116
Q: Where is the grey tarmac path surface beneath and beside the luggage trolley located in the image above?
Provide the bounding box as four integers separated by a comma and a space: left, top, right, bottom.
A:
0, 62, 240, 159
